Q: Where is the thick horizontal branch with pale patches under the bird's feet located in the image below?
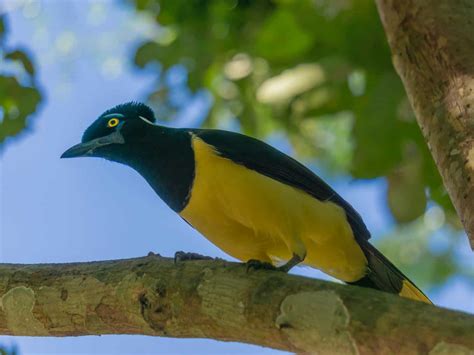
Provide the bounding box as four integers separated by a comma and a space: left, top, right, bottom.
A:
0, 255, 474, 354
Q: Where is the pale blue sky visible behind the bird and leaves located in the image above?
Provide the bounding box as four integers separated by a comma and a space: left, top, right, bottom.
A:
0, 1, 473, 354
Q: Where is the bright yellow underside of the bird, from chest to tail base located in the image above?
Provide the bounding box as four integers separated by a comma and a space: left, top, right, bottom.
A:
180, 137, 367, 282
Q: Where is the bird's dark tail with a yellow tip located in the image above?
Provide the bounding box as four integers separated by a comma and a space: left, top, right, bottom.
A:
351, 240, 432, 304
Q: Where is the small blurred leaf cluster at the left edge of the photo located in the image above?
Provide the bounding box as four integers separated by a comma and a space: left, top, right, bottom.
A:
0, 16, 42, 149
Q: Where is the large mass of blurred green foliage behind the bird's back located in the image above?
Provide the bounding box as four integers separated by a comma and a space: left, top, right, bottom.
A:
130, 0, 466, 290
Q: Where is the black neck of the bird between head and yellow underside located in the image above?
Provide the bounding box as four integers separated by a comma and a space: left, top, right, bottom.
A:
115, 126, 194, 212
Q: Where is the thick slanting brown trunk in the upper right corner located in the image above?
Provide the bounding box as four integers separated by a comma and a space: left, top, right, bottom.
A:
376, 0, 474, 248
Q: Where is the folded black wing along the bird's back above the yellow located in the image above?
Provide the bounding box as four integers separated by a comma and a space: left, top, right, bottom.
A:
191, 129, 370, 240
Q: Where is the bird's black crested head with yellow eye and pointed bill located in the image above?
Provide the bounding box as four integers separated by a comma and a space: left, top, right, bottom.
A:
61, 102, 155, 159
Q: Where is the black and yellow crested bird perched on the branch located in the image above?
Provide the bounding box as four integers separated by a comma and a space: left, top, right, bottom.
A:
61, 102, 431, 303
